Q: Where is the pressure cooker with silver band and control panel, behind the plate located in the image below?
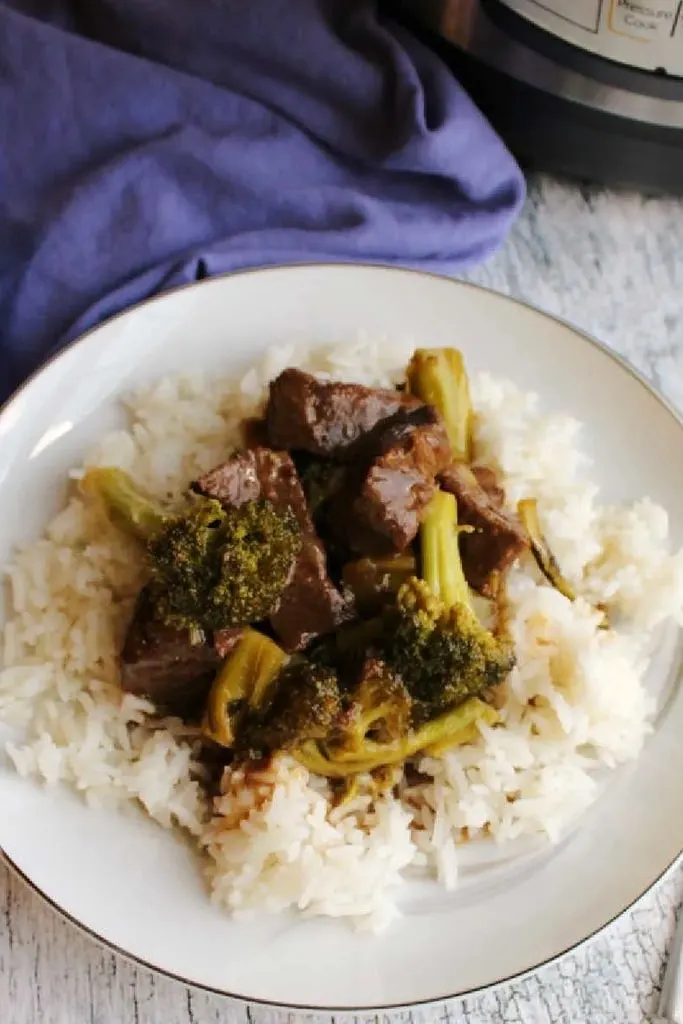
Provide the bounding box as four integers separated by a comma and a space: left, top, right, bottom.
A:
393, 0, 683, 194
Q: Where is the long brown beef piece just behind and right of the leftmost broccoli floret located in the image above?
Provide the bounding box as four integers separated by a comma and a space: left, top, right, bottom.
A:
195, 447, 348, 651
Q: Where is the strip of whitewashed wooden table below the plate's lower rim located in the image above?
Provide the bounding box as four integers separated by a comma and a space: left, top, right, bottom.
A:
0, 867, 683, 1024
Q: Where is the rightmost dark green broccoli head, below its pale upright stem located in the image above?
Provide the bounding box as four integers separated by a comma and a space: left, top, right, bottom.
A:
385, 579, 514, 722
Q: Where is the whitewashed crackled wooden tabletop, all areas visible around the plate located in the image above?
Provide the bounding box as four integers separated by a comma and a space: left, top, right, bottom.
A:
0, 180, 683, 1024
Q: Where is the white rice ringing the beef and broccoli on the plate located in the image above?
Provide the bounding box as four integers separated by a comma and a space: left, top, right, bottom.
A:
0, 337, 683, 931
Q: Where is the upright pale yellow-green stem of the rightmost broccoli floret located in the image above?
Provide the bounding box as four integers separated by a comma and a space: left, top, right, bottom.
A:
420, 490, 471, 608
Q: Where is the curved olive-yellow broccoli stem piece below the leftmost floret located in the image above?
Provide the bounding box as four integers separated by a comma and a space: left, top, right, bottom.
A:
204, 629, 288, 746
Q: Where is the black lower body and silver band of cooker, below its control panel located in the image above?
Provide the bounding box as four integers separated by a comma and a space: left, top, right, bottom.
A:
389, 0, 683, 194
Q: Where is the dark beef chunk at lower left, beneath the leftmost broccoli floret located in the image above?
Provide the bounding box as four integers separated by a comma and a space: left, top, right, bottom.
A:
121, 588, 221, 718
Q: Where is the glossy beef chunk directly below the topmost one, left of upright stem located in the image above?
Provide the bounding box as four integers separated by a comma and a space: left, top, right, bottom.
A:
335, 406, 452, 556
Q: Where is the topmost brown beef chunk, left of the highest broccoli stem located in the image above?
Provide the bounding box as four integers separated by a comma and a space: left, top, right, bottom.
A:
266, 370, 421, 462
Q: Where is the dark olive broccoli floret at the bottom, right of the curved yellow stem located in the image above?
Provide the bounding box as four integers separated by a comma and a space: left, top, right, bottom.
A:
237, 658, 341, 757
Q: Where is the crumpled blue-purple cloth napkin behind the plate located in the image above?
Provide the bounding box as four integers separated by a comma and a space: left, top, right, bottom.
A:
0, 0, 524, 398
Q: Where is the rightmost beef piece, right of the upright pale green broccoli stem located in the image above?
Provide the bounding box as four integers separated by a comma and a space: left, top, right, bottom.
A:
439, 463, 528, 597
